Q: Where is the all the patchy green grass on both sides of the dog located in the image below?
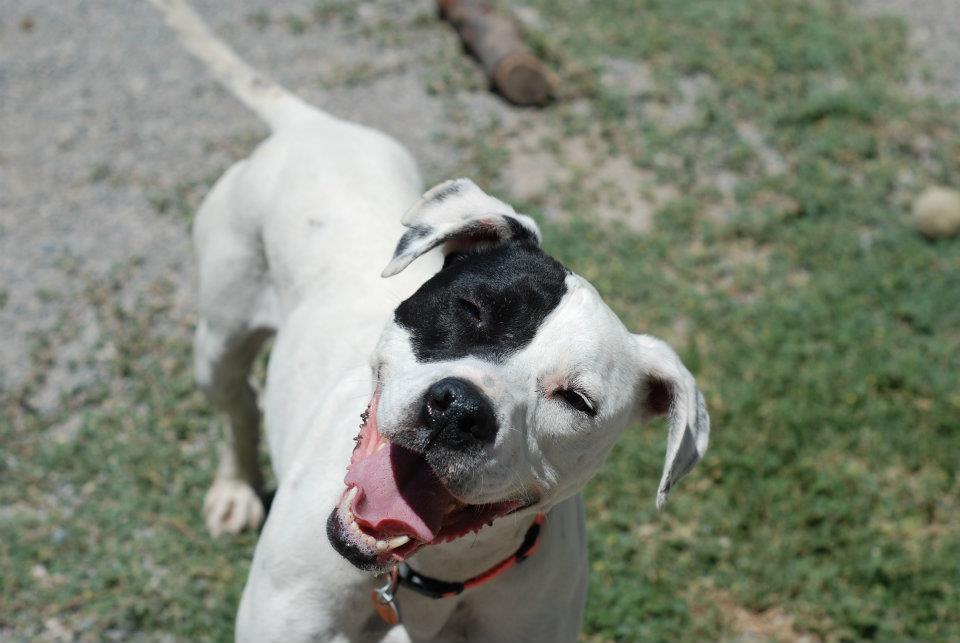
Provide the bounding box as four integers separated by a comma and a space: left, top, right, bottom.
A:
0, 0, 960, 641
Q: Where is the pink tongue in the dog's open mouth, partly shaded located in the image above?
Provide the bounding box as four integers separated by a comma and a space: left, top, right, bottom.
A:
344, 444, 460, 542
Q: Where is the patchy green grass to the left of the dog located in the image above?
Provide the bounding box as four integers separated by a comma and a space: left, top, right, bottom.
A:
0, 274, 255, 640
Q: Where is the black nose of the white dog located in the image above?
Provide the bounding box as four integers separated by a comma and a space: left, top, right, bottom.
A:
423, 377, 497, 448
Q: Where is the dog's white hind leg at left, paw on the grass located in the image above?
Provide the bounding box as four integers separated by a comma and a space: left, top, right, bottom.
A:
194, 169, 274, 536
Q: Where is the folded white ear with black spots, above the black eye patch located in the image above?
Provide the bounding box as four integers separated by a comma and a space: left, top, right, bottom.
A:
382, 179, 540, 277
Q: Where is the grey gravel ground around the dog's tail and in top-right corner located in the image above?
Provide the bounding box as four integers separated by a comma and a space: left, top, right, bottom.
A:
0, 0, 960, 402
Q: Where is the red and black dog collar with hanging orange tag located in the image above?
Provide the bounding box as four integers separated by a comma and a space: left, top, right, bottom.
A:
370, 513, 546, 625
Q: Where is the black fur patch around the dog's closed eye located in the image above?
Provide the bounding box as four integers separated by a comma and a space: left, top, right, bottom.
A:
394, 240, 567, 362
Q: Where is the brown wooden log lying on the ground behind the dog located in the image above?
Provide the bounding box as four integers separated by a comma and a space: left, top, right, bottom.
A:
437, 0, 554, 106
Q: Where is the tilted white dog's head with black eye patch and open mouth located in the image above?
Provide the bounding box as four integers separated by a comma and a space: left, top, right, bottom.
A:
328, 179, 709, 569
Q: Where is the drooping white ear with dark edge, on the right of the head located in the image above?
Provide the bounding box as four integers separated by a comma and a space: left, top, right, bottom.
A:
634, 335, 710, 509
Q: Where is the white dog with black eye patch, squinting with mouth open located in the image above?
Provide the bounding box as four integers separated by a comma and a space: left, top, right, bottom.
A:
151, 0, 710, 643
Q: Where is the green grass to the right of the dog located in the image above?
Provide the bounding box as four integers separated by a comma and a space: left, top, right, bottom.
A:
506, 0, 960, 641
